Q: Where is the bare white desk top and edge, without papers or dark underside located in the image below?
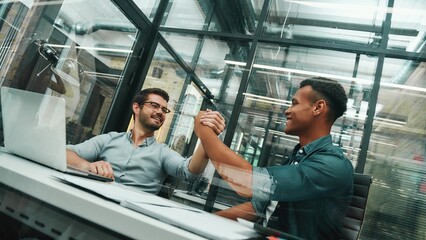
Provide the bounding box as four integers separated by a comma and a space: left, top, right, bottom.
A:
0, 149, 205, 239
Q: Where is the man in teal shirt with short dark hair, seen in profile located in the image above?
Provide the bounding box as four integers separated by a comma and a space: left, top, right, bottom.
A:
195, 78, 353, 239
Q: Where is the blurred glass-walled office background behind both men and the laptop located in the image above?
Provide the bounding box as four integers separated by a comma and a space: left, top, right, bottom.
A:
0, 0, 426, 239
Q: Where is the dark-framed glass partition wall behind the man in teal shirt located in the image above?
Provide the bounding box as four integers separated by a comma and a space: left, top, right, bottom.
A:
155, 0, 426, 239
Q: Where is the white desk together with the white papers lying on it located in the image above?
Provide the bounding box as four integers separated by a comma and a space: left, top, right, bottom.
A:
0, 152, 258, 240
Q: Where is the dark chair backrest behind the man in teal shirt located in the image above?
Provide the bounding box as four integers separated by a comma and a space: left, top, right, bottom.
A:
342, 173, 372, 240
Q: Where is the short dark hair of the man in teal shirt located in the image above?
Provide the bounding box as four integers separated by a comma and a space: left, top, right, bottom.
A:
300, 77, 348, 122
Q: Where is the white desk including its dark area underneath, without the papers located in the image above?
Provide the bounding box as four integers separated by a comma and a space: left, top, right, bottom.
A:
0, 149, 205, 240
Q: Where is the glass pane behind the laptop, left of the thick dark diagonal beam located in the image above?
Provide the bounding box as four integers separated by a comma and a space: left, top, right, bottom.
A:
0, 0, 138, 143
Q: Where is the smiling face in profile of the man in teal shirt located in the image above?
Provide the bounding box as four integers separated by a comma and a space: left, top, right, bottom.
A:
284, 86, 315, 136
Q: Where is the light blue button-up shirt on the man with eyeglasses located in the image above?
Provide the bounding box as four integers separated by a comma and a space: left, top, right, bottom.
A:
67, 132, 200, 194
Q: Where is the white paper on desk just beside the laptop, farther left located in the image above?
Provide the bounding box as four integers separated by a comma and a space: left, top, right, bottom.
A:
60, 175, 177, 206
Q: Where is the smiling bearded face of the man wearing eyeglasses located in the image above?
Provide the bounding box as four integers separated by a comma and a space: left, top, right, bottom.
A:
134, 94, 167, 131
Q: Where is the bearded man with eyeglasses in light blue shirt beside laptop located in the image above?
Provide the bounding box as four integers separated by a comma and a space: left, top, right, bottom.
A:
67, 88, 225, 194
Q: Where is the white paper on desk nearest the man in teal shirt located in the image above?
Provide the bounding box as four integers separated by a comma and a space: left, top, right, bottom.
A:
120, 201, 259, 240
